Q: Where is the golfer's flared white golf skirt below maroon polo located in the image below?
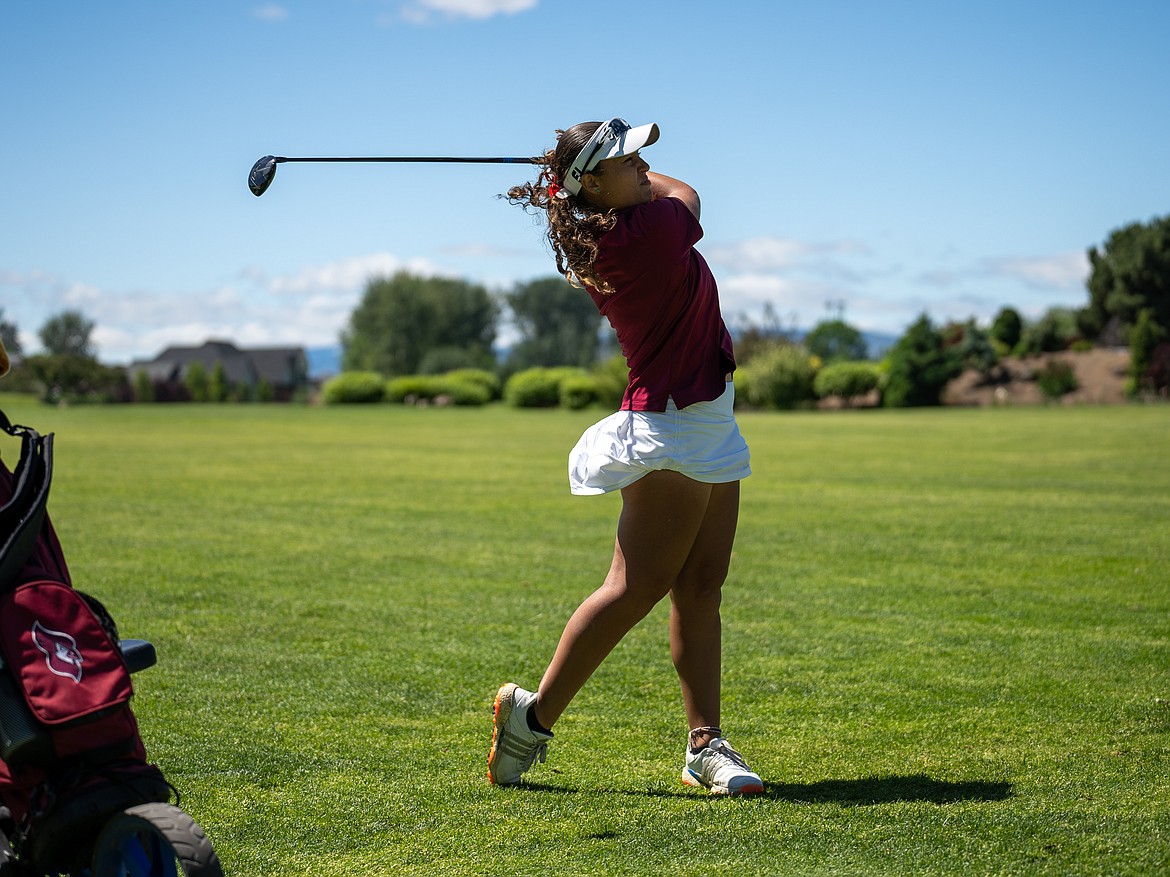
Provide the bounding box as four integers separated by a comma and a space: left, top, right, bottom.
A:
569, 381, 751, 496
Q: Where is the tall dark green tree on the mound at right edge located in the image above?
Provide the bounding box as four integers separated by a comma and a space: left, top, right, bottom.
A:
1080, 216, 1170, 344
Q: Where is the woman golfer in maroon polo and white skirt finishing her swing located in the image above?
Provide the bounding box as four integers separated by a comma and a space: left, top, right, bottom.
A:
488, 118, 764, 794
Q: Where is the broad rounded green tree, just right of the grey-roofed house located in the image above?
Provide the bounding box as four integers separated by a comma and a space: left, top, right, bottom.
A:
342, 271, 498, 377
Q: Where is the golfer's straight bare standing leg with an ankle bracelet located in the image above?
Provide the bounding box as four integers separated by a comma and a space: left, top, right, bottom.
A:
670, 482, 739, 745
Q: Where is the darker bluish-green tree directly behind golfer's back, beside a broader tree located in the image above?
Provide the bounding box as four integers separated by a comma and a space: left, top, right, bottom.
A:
504, 277, 601, 372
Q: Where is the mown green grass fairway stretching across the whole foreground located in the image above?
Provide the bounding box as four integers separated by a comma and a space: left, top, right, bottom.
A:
0, 395, 1170, 877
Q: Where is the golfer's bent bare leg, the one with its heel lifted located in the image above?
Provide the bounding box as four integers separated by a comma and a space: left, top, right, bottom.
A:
535, 471, 711, 727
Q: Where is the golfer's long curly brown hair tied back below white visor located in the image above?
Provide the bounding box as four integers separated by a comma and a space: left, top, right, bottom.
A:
505, 122, 618, 295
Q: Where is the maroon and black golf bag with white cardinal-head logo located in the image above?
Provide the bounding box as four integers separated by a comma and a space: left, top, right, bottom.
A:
0, 412, 173, 875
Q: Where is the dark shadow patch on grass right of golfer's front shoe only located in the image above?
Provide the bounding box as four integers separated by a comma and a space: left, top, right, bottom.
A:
764, 774, 1012, 807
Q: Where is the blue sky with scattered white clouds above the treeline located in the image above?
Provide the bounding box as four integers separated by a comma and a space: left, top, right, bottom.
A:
0, 0, 1170, 362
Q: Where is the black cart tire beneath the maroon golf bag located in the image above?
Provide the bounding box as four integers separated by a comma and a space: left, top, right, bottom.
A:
94, 803, 223, 877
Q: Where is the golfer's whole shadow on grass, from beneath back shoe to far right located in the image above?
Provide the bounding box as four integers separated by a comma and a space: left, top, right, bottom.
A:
517, 774, 1012, 807
